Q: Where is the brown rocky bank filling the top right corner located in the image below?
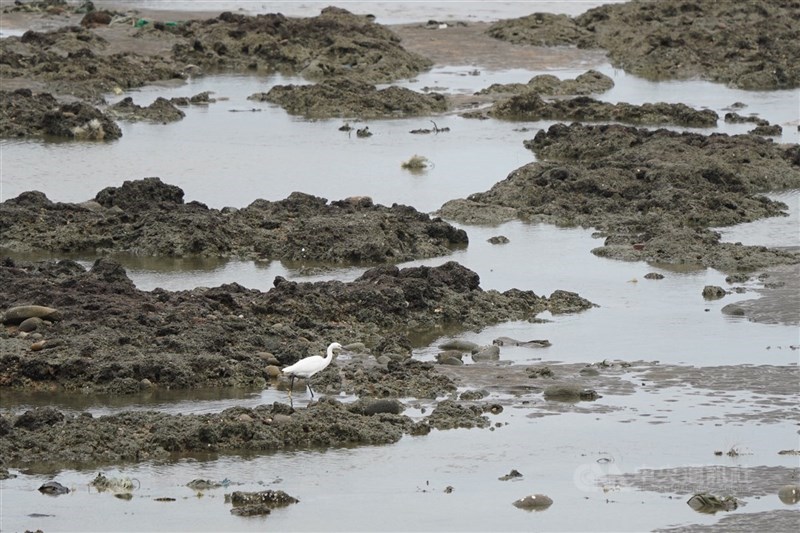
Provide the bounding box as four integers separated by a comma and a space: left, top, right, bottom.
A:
488, 0, 800, 90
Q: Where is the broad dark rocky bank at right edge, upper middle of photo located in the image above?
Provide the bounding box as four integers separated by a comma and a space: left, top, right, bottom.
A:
439, 124, 800, 272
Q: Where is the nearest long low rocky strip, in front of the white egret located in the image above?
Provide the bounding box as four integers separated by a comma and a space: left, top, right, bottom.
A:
0, 399, 422, 468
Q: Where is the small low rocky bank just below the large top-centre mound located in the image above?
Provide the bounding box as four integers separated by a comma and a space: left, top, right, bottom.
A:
249, 79, 447, 119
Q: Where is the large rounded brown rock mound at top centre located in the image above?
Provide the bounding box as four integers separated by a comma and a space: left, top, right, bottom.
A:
173, 7, 432, 83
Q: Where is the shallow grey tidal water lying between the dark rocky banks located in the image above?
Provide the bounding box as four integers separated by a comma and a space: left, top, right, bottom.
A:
0, 2, 800, 532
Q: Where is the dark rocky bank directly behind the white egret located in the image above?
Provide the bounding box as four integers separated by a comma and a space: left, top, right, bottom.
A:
0, 258, 592, 397
